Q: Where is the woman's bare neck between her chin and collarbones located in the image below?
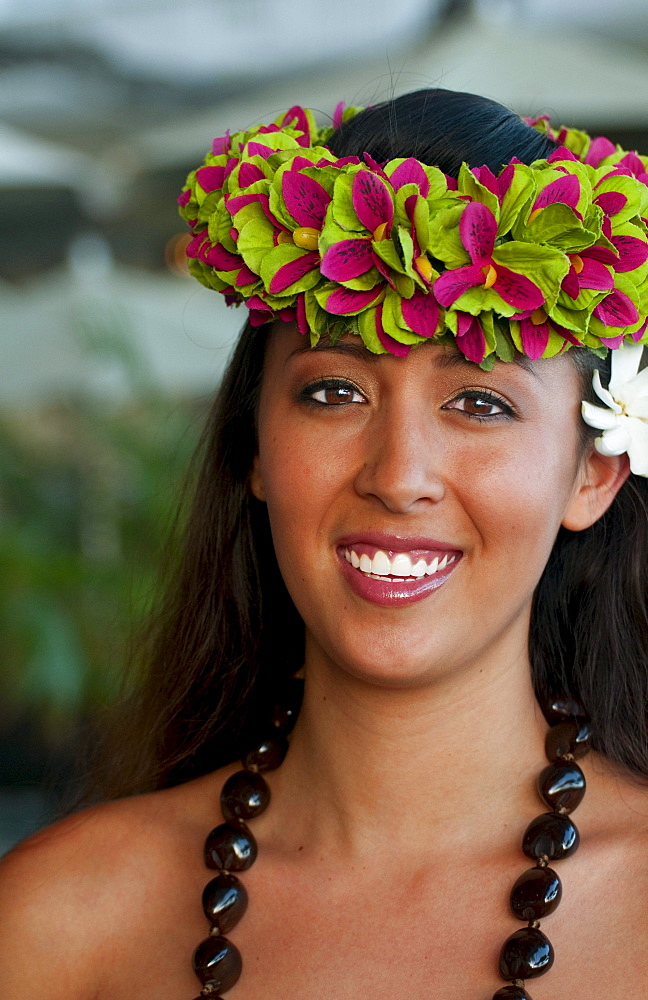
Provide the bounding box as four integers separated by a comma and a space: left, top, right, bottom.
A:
268, 632, 547, 860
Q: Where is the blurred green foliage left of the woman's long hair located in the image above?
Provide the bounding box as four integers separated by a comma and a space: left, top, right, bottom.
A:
0, 316, 206, 742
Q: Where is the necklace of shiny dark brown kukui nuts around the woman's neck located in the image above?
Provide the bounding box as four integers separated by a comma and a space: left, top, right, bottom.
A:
187, 679, 591, 1000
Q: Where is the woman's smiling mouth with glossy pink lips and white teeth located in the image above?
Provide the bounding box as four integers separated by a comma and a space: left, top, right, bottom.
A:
337, 535, 463, 606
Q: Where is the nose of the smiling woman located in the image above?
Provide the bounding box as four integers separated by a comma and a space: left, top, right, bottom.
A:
355, 408, 445, 513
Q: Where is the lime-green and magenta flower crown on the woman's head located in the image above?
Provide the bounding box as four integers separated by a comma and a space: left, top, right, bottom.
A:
178, 105, 648, 368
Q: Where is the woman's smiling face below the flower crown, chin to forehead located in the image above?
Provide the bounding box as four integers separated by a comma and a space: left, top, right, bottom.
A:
251, 324, 609, 685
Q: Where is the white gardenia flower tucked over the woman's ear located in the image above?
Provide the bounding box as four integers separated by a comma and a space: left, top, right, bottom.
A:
581, 344, 648, 476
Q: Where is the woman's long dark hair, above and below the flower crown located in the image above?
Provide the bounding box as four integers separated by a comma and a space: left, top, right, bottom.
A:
93, 90, 648, 795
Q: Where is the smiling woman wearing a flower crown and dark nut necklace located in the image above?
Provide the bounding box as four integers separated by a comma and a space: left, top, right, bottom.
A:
0, 91, 648, 1000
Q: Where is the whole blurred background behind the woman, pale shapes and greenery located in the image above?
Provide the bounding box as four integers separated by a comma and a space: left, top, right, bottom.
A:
0, 0, 648, 853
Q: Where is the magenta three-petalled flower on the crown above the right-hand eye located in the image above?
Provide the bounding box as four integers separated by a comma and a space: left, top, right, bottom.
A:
434, 201, 544, 311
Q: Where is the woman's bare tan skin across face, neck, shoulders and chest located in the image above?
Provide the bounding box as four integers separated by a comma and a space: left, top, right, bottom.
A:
0, 325, 648, 1000
